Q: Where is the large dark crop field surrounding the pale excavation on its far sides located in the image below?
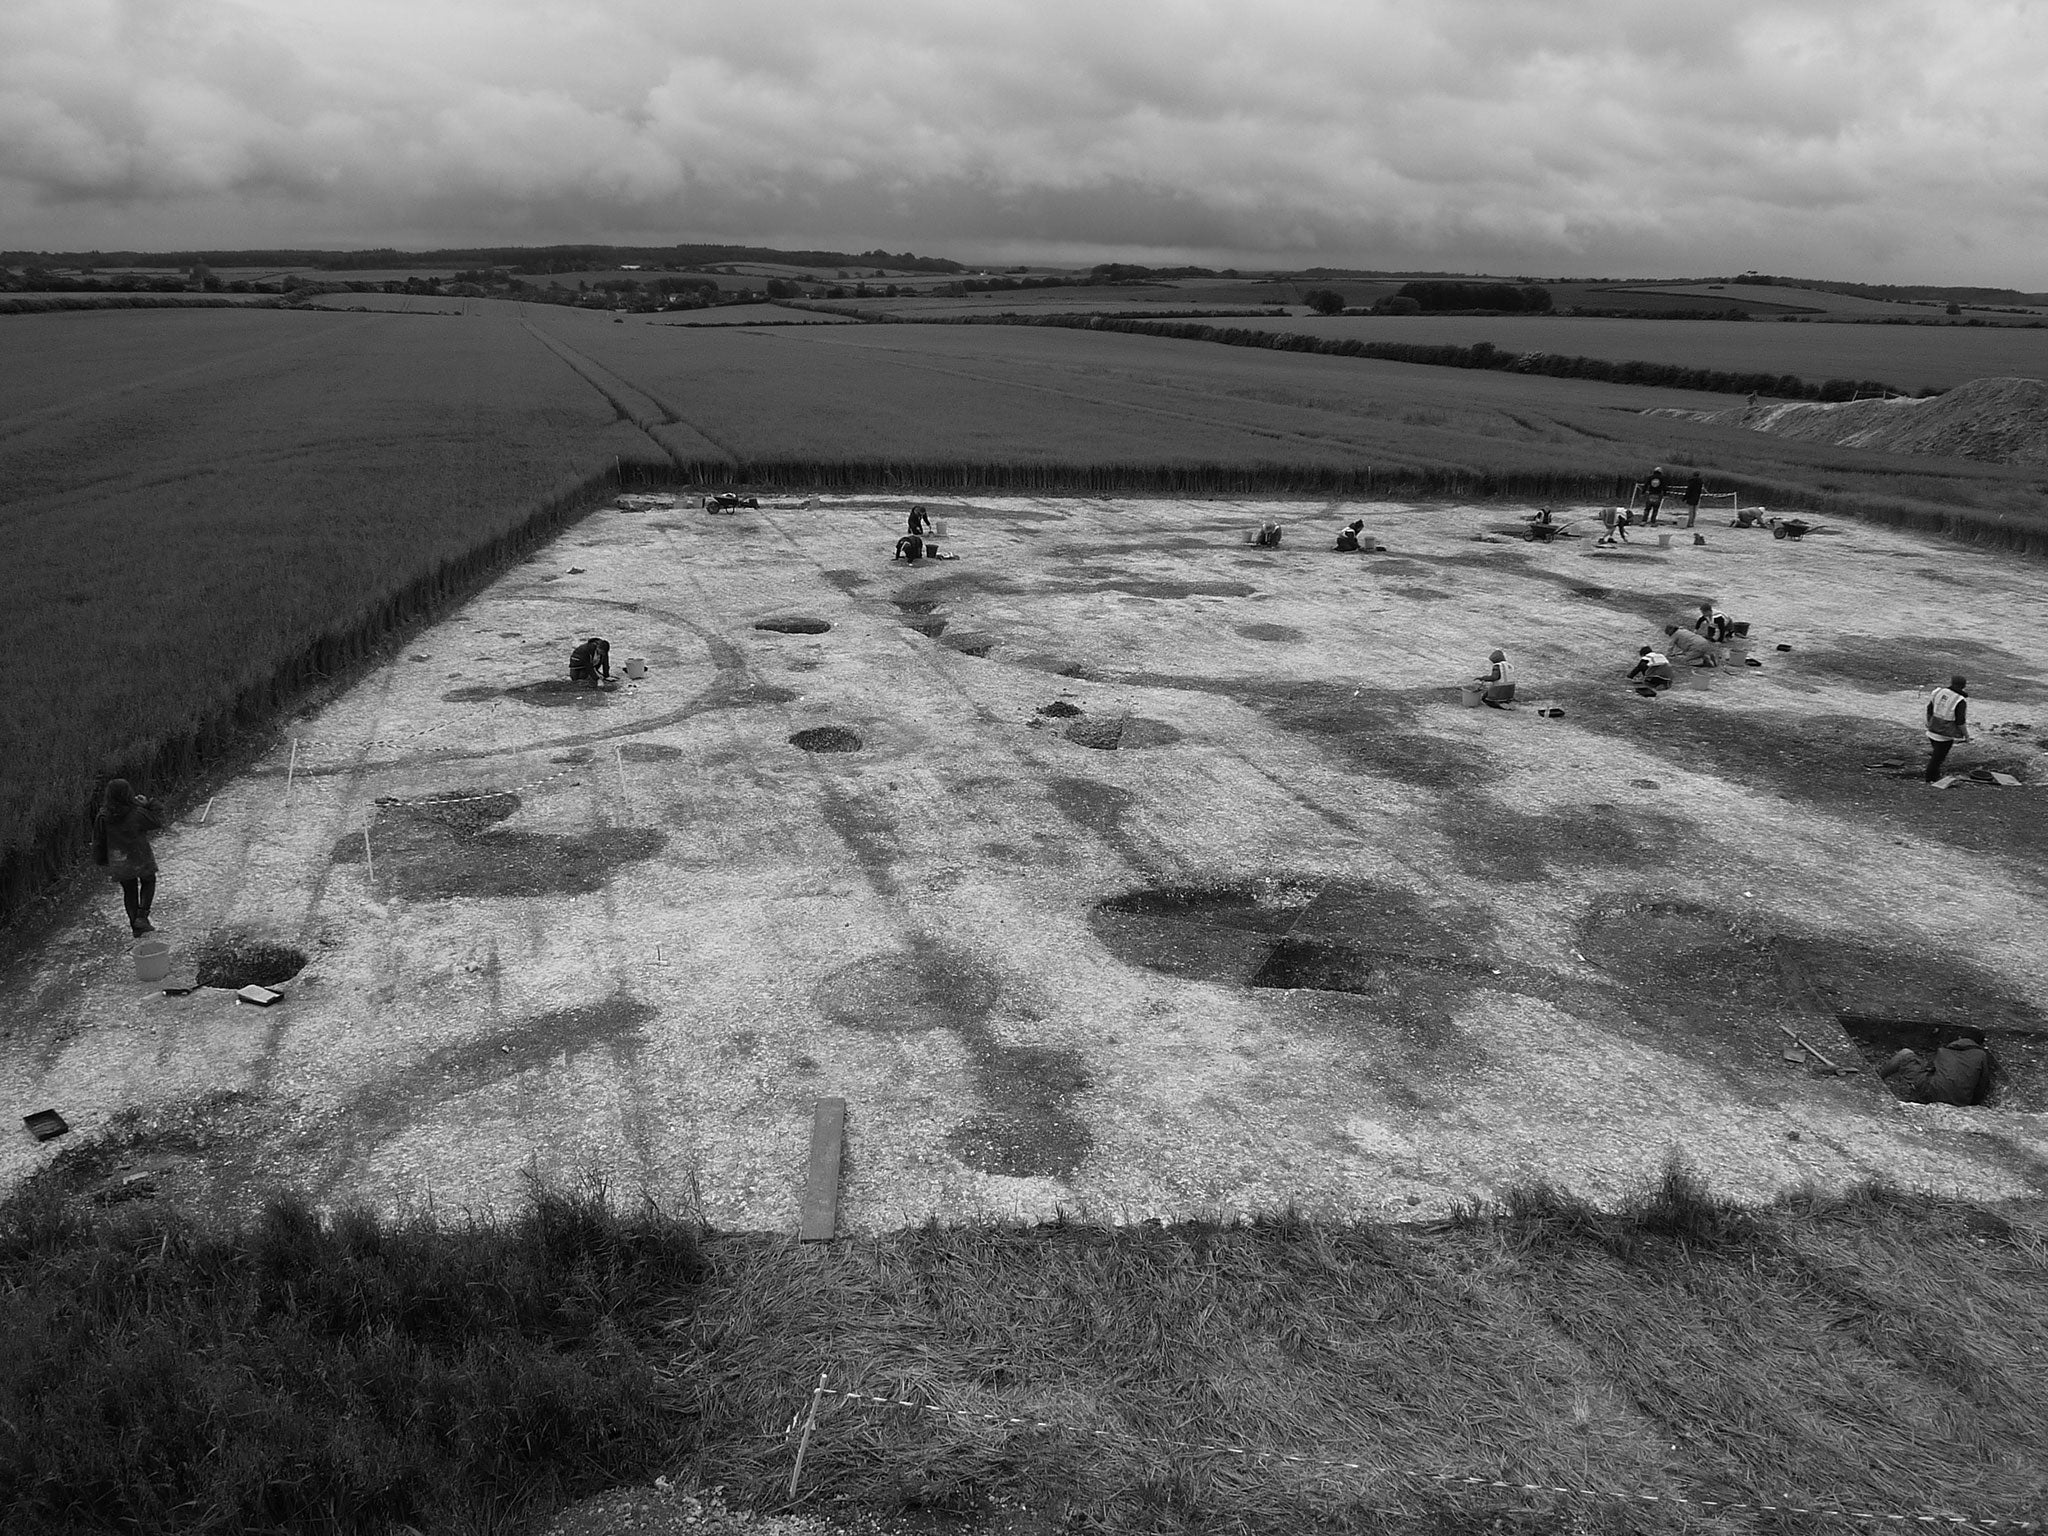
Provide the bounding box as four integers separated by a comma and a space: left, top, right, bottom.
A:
0, 301, 2048, 925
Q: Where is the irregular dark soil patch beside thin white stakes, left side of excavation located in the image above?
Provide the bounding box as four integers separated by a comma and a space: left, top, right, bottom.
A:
330, 795, 668, 901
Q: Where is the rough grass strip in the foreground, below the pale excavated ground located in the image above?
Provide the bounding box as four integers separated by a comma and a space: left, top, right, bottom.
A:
0, 1147, 2048, 1534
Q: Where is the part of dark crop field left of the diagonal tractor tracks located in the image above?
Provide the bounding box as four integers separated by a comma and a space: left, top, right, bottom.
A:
0, 309, 647, 921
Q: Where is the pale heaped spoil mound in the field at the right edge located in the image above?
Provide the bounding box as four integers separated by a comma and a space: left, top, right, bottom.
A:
1653, 379, 2048, 467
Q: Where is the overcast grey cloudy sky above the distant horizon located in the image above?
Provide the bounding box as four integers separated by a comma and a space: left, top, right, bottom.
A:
0, 0, 2048, 291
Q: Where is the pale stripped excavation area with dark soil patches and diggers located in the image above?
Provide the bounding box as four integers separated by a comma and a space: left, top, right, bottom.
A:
0, 494, 2048, 1233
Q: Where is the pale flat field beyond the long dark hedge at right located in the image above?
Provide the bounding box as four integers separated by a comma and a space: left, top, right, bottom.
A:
1187, 315, 2048, 393
